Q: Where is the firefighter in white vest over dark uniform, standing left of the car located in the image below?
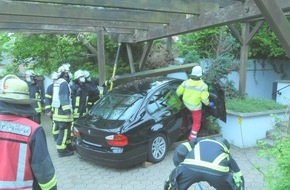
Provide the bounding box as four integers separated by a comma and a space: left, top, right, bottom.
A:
51, 64, 74, 157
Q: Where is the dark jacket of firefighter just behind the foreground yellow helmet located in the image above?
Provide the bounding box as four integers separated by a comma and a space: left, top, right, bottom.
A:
27, 82, 43, 113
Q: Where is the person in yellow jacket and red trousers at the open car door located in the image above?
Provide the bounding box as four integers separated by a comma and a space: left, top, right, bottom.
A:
176, 66, 214, 140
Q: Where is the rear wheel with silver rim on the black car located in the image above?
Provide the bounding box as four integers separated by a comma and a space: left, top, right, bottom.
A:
148, 133, 168, 163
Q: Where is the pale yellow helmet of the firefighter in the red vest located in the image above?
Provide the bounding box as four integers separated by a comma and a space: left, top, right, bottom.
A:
0, 75, 37, 105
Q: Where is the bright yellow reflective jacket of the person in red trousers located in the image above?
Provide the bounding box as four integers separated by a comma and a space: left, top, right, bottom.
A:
176, 79, 209, 111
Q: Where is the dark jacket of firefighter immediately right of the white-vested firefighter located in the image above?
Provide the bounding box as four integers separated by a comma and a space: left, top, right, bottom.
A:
71, 83, 89, 119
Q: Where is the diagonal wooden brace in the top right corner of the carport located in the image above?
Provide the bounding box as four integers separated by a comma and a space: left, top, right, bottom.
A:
254, 0, 290, 58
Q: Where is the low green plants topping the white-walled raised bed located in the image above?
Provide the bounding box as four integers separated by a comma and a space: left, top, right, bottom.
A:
226, 97, 287, 113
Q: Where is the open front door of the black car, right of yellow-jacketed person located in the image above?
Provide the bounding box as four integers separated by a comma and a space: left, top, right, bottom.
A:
203, 84, 227, 122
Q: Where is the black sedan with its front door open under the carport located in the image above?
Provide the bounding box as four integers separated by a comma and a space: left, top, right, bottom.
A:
74, 77, 226, 168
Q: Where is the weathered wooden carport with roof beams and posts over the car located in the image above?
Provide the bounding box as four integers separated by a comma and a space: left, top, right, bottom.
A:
0, 0, 290, 95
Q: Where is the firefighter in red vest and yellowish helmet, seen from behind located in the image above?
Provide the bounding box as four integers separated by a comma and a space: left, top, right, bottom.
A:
0, 75, 57, 190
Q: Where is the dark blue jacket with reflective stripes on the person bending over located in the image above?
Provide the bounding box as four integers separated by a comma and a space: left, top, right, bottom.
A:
173, 138, 240, 172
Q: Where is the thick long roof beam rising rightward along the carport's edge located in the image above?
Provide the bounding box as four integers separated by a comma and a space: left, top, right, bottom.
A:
124, 0, 290, 42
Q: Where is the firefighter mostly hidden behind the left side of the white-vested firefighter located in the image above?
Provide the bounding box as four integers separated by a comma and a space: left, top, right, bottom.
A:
45, 72, 59, 142
